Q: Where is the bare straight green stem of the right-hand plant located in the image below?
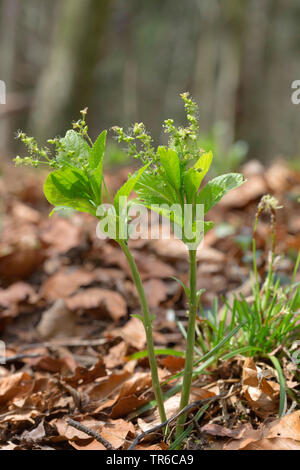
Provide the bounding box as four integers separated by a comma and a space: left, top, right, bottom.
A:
176, 250, 197, 439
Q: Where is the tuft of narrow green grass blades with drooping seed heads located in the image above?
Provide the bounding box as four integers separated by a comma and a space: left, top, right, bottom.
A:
196, 196, 300, 365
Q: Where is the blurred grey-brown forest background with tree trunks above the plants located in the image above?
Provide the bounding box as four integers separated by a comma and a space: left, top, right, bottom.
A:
0, 0, 300, 169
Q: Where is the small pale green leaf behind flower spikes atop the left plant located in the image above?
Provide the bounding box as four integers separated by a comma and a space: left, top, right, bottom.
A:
57, 130, 90, 167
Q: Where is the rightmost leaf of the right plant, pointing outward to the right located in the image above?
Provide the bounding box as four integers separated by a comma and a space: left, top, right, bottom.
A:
197, 173, 245, 214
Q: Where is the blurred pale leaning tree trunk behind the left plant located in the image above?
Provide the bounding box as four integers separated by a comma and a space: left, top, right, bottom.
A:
29, 0, 109, 141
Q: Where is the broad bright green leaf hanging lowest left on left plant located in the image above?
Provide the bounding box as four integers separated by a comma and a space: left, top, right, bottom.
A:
44, 168, 96, 215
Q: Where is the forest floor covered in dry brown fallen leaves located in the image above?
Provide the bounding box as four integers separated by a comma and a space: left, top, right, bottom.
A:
0, 162, 300, 450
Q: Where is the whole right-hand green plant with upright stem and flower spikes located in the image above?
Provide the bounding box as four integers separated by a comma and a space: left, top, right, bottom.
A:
114, 93, 244, 444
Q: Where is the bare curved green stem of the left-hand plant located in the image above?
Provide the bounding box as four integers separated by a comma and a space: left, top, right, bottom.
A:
118, 240, 167, 423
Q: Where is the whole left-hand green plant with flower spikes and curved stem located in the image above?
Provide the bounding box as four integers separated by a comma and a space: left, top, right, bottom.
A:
15, 110, 166, 422
